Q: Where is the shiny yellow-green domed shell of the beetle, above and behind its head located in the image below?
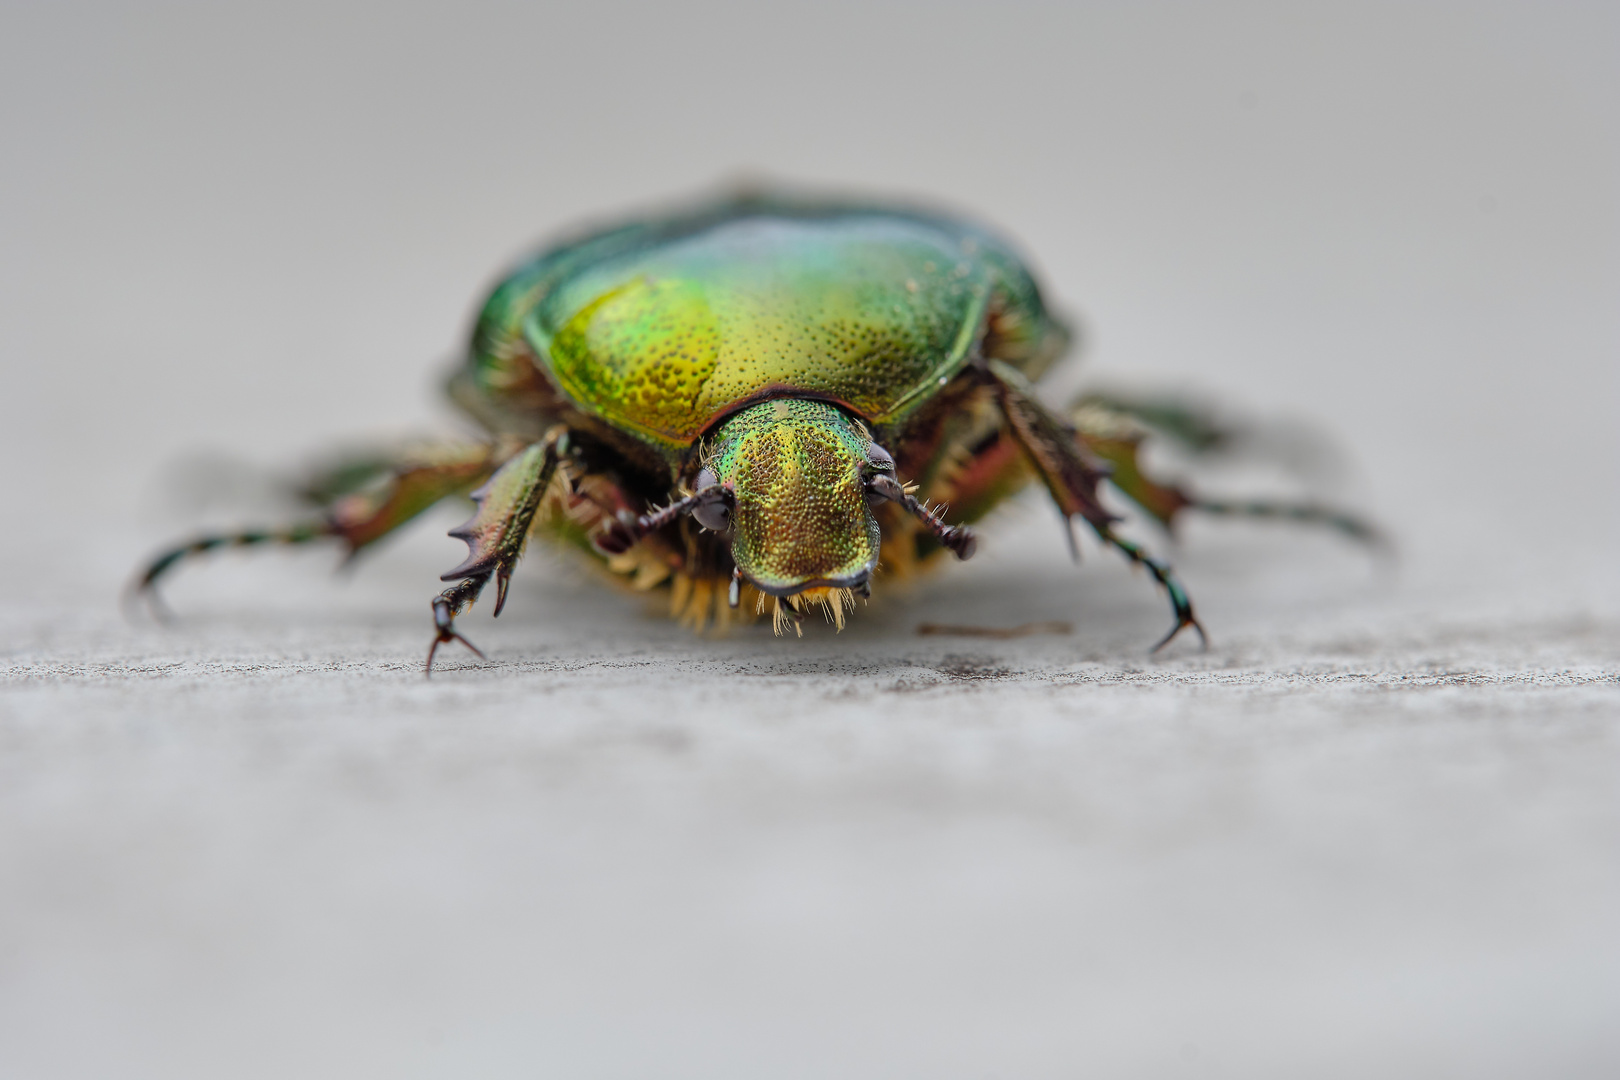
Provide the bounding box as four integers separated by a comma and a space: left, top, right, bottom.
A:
455, 199, 1068, 458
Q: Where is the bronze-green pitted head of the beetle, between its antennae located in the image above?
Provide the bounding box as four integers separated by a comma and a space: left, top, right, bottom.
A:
705, 398, 881, 596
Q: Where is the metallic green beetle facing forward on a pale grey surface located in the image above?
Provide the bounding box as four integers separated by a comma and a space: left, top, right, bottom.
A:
138, 196, 1371, 672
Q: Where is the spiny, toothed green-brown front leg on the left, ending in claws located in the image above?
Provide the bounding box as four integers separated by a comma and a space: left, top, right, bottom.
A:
426, 427, 569, 675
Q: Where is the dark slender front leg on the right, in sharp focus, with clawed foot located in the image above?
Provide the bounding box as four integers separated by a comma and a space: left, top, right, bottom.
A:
983, 359, 1207, 653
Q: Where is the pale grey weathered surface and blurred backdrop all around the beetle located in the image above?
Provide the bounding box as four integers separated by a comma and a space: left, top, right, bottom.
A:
9, 5, 1620, 1080
